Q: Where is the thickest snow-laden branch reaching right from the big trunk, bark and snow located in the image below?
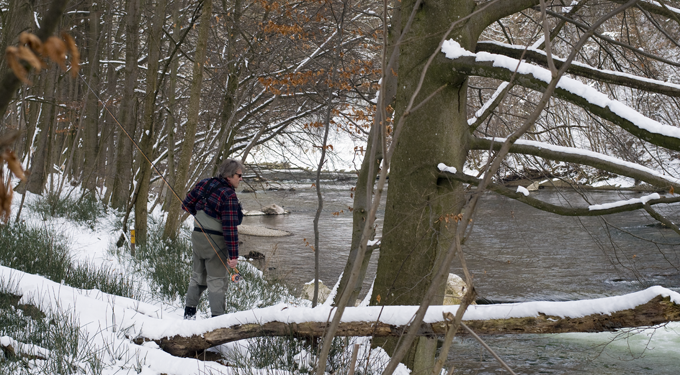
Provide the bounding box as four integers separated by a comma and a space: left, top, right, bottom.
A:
442, 40, 680, 151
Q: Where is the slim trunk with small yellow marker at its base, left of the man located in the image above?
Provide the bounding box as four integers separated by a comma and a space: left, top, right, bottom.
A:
135, 0, 167, 245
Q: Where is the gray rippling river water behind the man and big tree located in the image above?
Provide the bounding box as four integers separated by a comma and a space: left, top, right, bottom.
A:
239, 178, 680, 374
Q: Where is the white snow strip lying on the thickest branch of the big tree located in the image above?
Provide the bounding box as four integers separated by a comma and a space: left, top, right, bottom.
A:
442, 40, 680, 139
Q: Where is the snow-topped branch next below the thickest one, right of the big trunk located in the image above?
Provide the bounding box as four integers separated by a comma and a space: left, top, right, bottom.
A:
470, 137, 680, 191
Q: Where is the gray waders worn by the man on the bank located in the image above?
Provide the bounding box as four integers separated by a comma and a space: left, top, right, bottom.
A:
186, 211, 229, 316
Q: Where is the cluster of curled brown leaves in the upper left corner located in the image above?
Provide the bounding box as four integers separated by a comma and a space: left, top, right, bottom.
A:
5, 32, 80, 85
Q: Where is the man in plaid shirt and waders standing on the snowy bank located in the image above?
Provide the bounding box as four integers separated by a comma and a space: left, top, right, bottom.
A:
182, 159, 244, 319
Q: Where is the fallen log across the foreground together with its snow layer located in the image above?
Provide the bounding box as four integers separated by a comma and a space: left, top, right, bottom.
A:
135, 287, 680, 356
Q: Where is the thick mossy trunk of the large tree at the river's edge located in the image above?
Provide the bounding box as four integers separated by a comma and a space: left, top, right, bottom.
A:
371, 0, 475, 374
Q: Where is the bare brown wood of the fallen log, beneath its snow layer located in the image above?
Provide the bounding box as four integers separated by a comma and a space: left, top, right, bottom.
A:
135, 295, 680, 356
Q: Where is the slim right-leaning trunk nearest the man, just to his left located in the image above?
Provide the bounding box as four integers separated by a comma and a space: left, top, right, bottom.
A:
163, 0, 212, 238
